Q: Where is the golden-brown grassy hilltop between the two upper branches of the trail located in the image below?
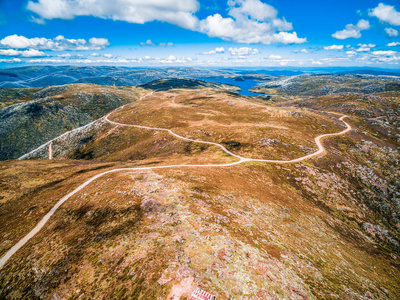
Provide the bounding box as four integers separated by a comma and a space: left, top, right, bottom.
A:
106, 90, 341, 160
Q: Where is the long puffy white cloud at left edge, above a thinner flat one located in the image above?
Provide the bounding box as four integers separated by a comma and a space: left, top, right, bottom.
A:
0, 34, 109, 51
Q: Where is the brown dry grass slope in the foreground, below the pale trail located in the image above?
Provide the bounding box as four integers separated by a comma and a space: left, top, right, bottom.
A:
0, 164, 399, 299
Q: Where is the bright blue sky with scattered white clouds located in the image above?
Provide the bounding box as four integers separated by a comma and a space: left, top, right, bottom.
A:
0, 0, 400, 68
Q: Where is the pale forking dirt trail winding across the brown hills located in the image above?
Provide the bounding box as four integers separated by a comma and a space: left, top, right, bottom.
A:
0, 92, 352, 269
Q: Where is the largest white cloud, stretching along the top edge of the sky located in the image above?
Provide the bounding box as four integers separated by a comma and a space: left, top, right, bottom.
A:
27, 0, 307, 44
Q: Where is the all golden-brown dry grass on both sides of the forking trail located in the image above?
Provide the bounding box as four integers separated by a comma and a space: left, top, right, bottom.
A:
0, 86, 400, 299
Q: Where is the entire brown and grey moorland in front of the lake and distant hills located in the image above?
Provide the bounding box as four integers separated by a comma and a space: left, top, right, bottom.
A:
0, 67, 400, 299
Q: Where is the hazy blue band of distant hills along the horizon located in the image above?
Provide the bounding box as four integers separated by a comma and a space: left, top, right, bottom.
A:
0, 66, 400, 88
